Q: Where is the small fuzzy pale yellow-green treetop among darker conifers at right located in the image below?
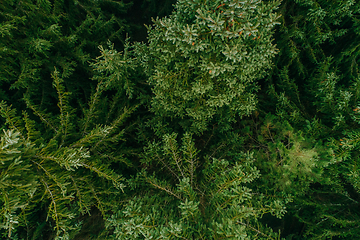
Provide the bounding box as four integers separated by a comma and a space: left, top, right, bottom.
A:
242, 114, 336, 197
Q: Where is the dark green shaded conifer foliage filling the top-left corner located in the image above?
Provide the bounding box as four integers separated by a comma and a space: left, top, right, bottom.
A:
0, 0, 127, 111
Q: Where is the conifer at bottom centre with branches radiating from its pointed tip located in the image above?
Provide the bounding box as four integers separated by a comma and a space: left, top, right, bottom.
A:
108, 133, 285, 239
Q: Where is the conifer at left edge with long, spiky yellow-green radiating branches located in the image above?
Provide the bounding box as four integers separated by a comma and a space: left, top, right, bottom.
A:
0, 53, 134, 239
